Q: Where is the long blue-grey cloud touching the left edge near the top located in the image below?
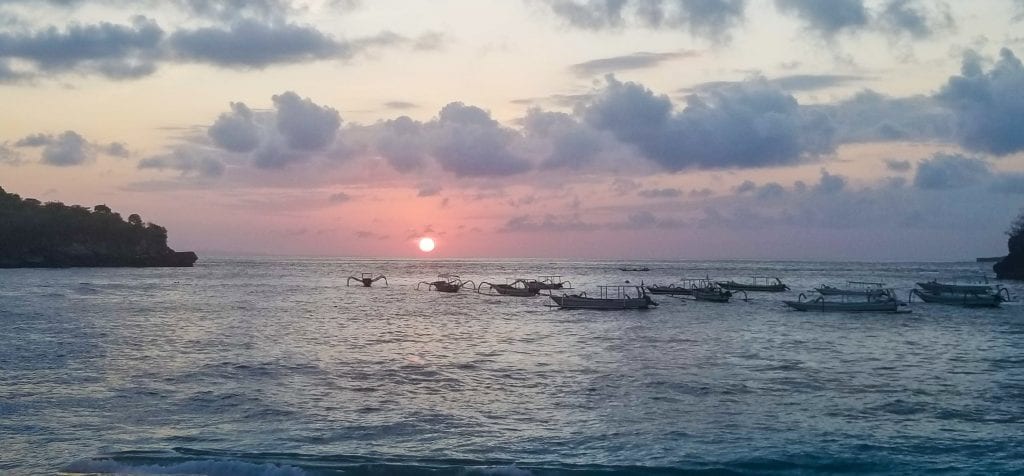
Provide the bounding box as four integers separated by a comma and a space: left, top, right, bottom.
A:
0, 16, 164, 79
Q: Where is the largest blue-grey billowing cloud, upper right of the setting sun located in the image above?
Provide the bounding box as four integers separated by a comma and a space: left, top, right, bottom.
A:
582, 76, 835, 171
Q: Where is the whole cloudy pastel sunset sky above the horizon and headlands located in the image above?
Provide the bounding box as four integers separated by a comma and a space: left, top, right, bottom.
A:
0, 0, 1024, 261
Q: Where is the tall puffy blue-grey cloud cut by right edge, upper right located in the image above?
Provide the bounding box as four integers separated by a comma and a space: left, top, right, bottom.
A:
936, 48, 1024, 156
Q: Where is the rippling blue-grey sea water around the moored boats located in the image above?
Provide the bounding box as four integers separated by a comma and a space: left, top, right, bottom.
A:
0, 258, 1024, 475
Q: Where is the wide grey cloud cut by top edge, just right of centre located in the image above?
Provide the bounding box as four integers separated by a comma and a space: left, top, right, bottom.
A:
545, 0, 746, 42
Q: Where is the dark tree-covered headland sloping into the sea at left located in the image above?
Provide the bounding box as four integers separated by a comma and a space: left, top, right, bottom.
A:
0, 187, 199, 268
